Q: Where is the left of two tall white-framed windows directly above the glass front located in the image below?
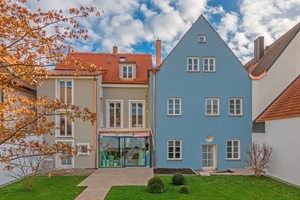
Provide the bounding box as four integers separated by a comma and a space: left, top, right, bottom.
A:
106, 101, 123, 128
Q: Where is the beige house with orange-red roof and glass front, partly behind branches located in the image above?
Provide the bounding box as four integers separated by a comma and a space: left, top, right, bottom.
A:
38, 46, 152, 168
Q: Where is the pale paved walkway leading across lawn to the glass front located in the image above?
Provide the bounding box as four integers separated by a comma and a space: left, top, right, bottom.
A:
76, 168, 153, 200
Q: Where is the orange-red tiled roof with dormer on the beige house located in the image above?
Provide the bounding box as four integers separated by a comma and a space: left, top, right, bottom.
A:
55, 52, 153, 84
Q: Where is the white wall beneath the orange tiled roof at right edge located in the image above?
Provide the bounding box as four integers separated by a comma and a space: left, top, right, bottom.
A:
266, 117, 300, 186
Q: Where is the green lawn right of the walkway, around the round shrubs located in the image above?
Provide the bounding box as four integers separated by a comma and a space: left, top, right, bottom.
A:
105, 175, 300, 200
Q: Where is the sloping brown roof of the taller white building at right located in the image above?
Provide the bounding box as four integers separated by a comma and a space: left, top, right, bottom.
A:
244, 23, 300, 76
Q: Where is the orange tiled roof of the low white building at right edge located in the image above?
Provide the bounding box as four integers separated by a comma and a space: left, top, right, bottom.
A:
254, 75, 300, 122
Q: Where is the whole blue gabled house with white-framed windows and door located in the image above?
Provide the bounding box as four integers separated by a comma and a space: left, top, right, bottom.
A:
150, 15, 252, 170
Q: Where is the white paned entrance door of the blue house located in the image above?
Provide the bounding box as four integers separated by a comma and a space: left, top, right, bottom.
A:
202, 144, 215, 170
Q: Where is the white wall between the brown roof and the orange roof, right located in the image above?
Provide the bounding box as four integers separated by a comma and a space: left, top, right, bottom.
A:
252, 33, 300, 119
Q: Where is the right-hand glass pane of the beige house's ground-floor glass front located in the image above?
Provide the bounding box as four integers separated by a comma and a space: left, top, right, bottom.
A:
125, 138, 146, 167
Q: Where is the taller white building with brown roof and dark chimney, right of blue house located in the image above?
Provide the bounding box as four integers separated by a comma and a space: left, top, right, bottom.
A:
245, 23, 300, 142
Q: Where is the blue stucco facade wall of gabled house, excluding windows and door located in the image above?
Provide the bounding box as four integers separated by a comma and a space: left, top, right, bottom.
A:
156, 18, 252, 170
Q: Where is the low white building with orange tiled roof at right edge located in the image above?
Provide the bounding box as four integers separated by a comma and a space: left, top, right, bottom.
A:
254, 75, 300, 186
